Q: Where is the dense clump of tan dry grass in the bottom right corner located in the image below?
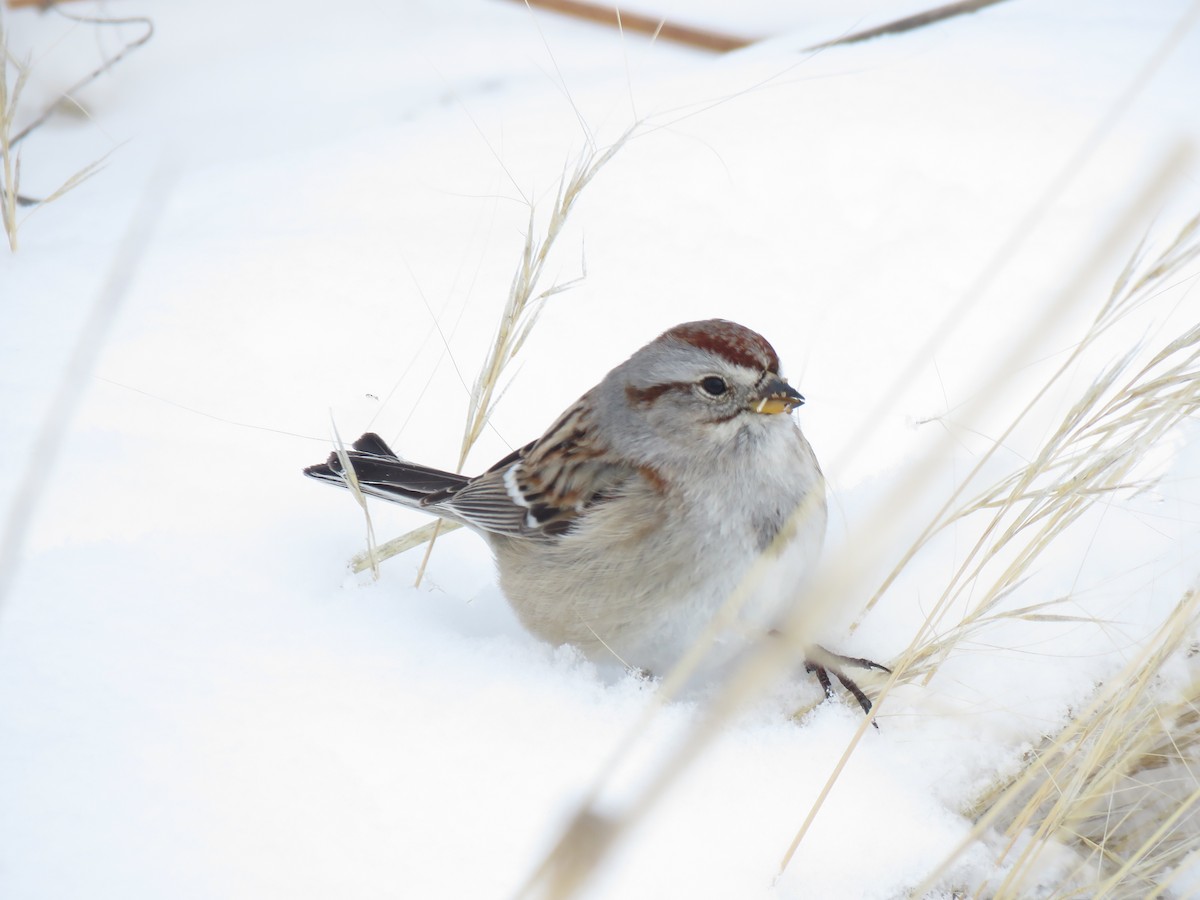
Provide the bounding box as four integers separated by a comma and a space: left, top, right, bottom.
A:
924, 589, 1200, 900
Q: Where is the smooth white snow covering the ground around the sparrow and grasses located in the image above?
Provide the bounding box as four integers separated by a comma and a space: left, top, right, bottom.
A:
0, 0, 1200, 900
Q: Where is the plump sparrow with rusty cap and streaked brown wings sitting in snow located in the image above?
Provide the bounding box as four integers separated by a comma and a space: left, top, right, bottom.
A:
305, 319, 888, 713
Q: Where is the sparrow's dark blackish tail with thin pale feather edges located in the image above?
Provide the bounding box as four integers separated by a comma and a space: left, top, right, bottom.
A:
304, 432, 467, 506
